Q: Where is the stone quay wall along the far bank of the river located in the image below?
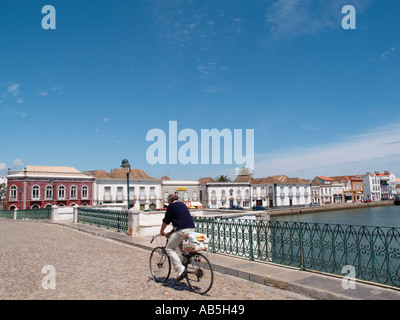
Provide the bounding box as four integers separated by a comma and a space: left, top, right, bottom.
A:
268, 201, 394, 217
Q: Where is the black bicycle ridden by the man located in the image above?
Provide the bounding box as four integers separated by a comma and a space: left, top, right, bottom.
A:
149, 234, 214, 295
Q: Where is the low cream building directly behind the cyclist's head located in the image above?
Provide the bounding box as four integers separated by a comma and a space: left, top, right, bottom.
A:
161, 176, 203, 208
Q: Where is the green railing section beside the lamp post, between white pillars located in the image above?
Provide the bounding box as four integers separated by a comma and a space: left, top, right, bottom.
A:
77, 208, 128, 232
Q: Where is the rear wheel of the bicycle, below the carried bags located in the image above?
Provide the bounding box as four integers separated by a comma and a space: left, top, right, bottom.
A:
186, 253, 214, 294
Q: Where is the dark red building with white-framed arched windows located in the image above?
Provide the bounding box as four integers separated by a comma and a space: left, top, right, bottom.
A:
6, 166, 94, 210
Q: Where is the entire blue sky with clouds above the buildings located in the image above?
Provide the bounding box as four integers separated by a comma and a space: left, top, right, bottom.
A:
0, 0, 400, 179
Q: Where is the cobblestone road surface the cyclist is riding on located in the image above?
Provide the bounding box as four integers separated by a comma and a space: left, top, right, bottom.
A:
0, 220, 305, 300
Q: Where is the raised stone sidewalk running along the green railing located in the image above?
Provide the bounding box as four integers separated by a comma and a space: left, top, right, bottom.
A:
57, 223, 400, 300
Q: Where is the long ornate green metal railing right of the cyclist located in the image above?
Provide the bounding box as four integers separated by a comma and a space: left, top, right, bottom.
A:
195, 218, 400, 287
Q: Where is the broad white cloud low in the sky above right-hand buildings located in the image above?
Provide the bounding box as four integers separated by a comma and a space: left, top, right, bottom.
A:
255, 123, 400, 177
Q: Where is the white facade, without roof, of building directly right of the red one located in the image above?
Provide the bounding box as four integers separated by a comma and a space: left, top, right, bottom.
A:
93, 179, 163, 210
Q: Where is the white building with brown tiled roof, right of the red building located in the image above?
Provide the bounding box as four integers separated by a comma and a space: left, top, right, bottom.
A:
86, 168, 163, 210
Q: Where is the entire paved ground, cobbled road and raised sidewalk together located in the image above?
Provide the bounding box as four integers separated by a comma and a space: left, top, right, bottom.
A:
0, 220, 400, 300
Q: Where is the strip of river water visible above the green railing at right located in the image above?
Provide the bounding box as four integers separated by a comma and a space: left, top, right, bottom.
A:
271, 206, 400, 228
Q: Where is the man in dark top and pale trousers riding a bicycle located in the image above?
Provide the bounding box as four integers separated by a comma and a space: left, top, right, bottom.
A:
160, 194, 195, 281
